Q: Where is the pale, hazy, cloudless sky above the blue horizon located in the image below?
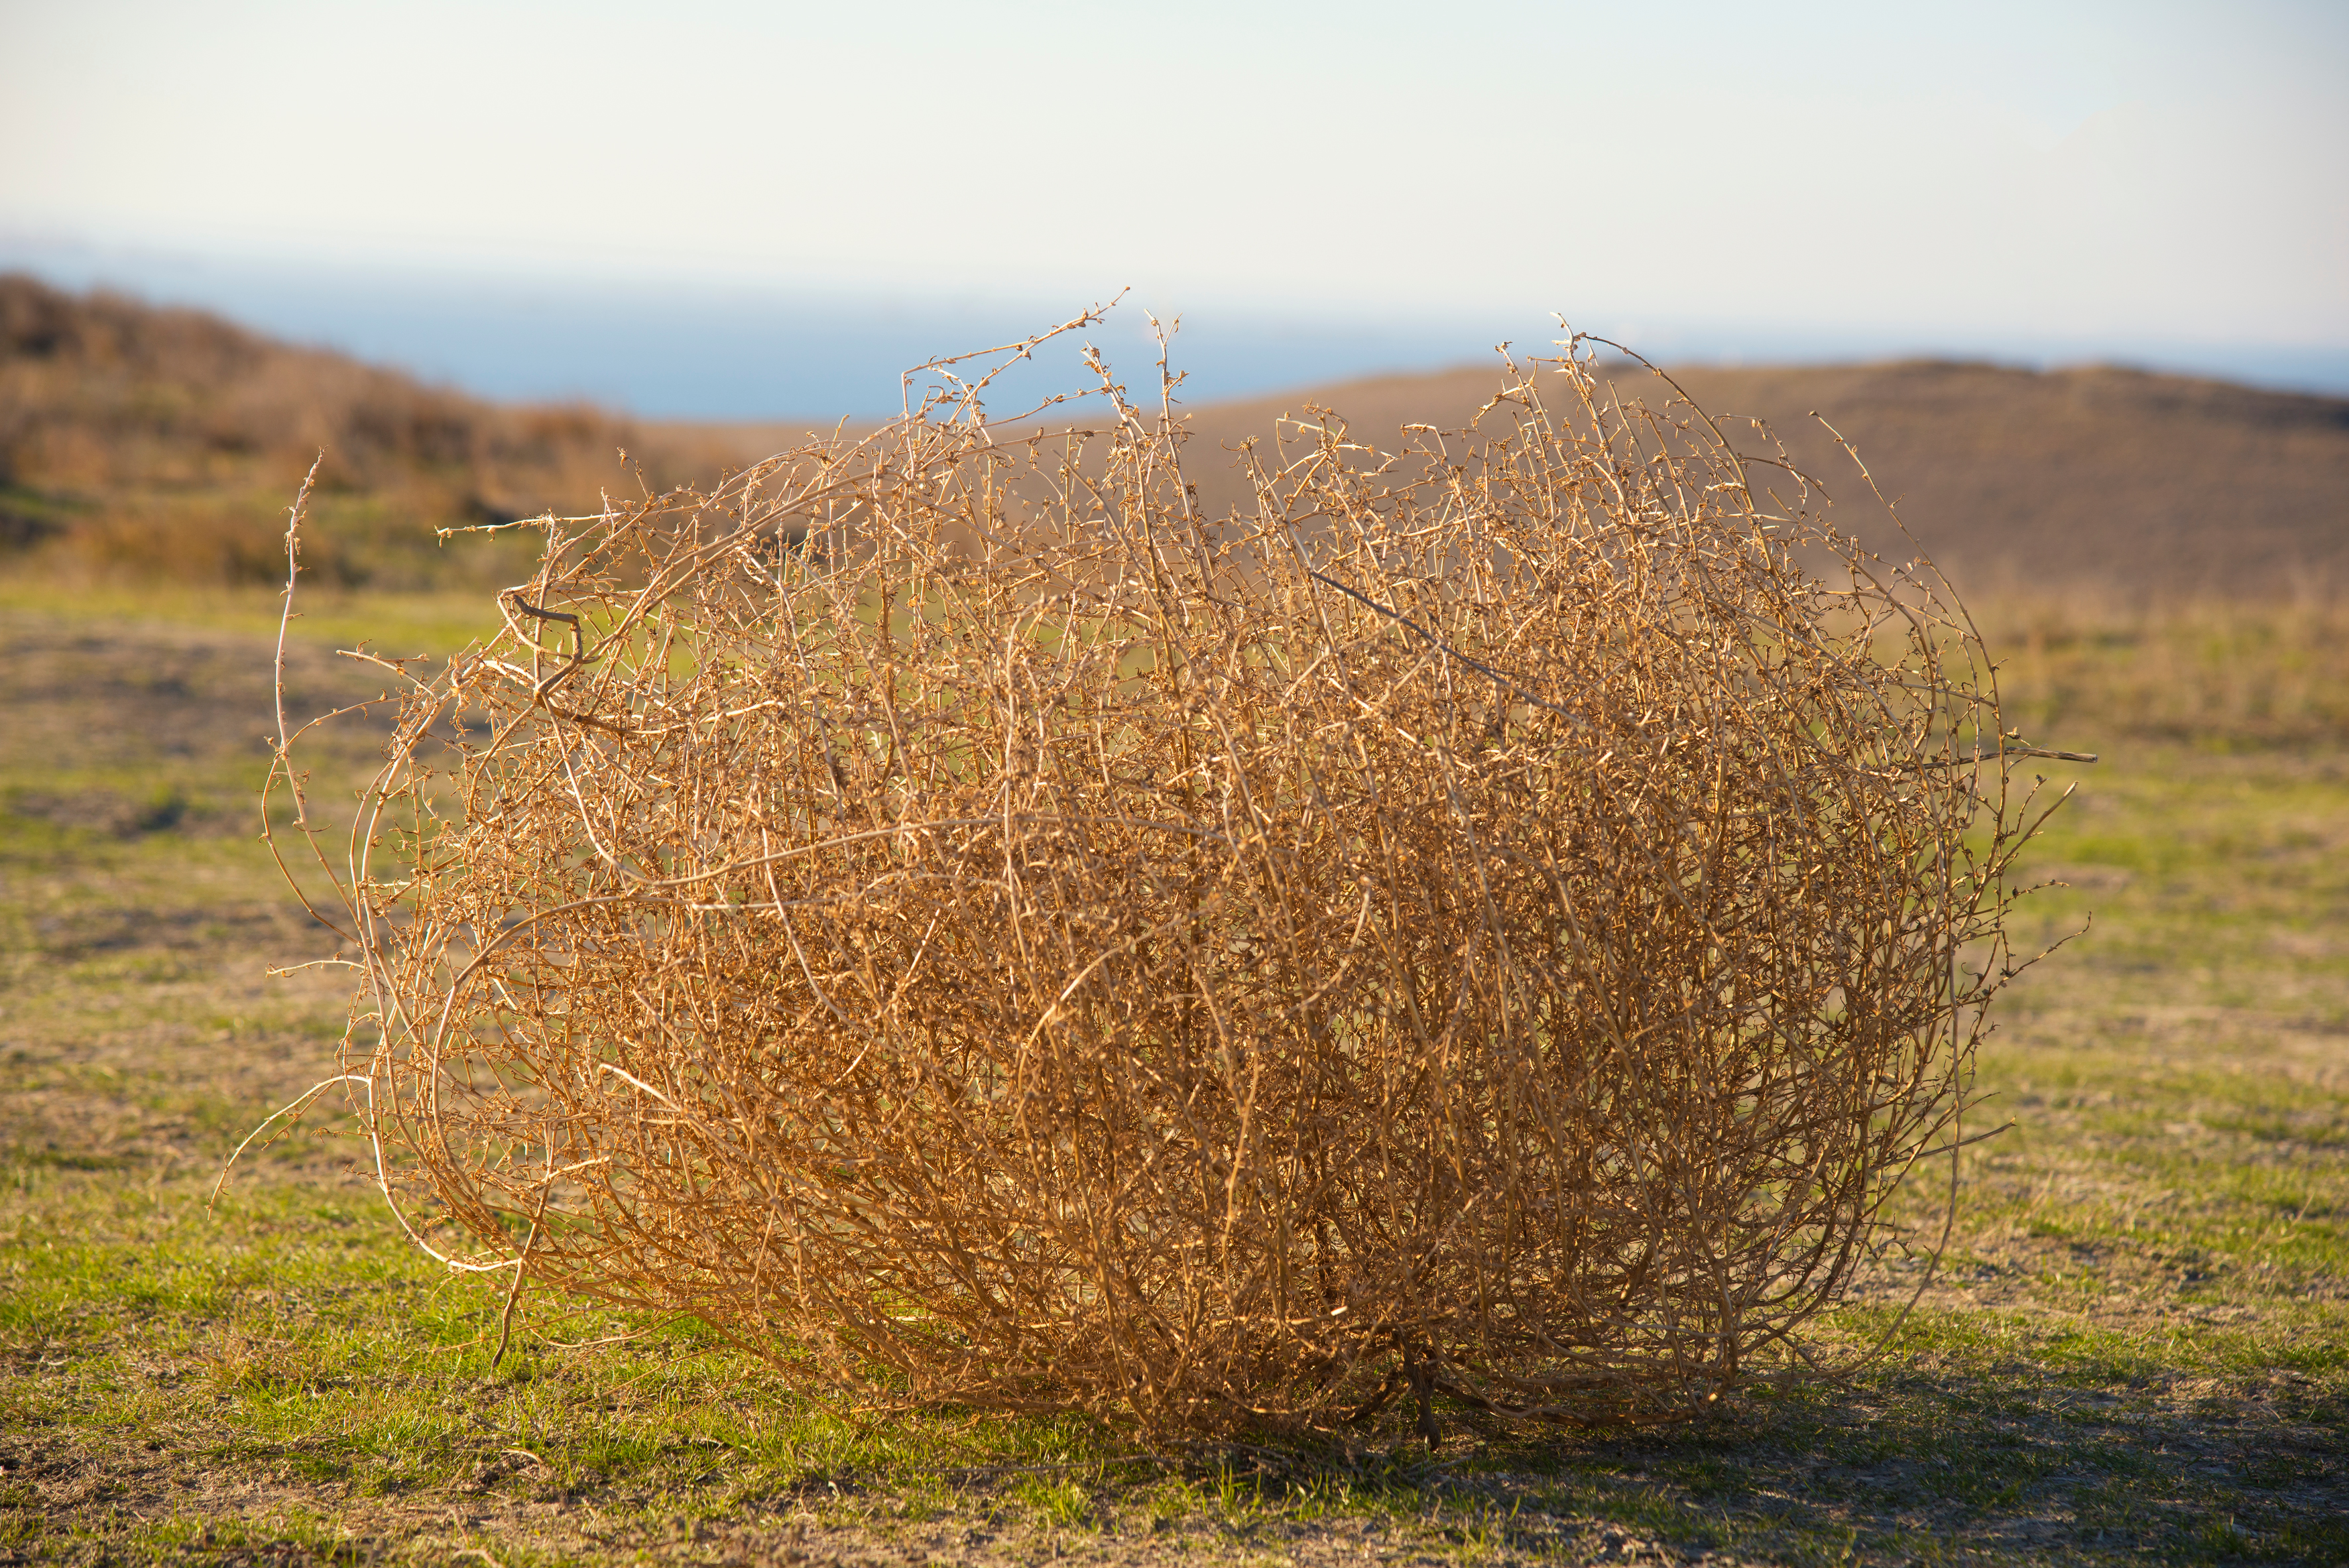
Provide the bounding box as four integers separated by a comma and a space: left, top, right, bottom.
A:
0, 0, 2349, 403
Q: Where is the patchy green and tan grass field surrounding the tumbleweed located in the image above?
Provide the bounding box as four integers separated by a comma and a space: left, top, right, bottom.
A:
0, 585, 2349, 1565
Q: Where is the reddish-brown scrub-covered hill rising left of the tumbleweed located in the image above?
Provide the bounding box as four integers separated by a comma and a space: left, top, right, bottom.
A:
0, 274, 735, 589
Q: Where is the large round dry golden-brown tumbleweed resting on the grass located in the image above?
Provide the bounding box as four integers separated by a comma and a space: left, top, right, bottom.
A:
262, 324, 2057, 1432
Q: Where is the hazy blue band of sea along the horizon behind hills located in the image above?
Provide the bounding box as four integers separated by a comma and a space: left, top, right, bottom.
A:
0, 235, 2349, 422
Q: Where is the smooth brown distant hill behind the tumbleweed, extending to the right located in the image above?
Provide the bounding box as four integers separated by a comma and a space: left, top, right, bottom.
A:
1186, 361, 2349, 601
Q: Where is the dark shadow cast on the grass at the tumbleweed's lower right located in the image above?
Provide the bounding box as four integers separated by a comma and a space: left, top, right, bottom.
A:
1305, 1361, 2349, 1561
